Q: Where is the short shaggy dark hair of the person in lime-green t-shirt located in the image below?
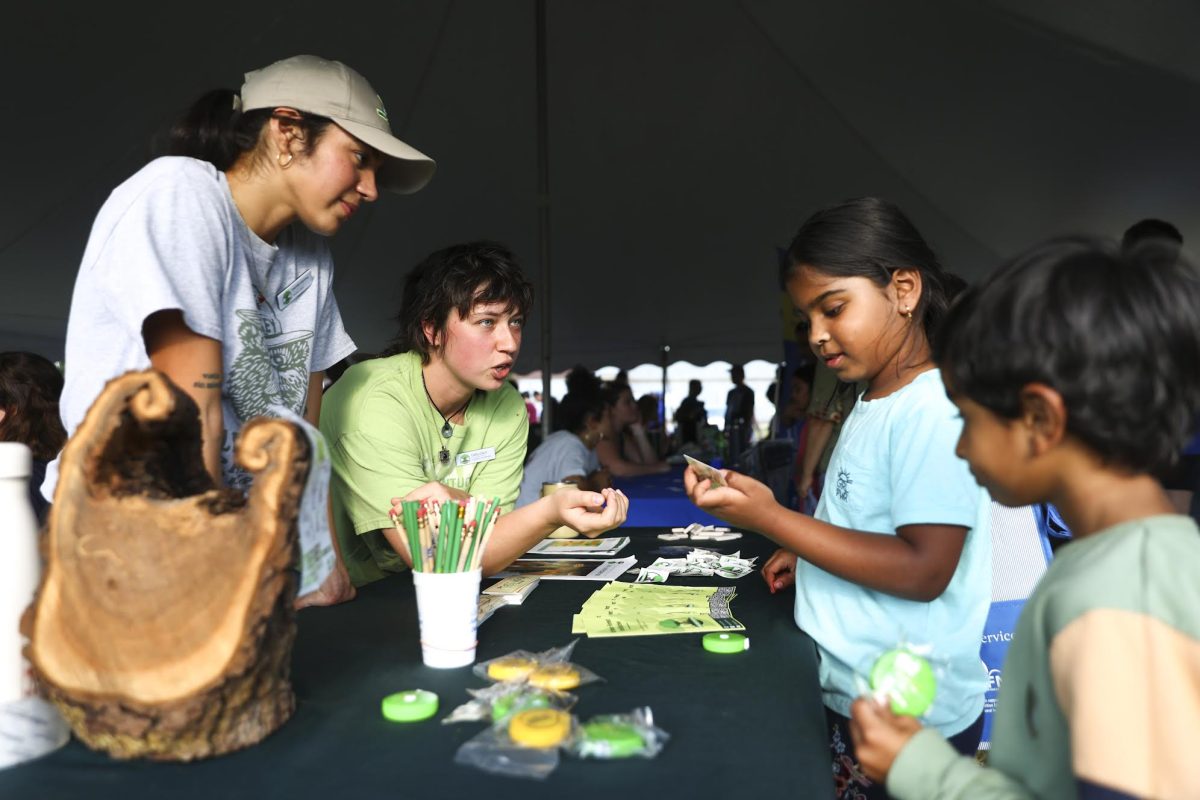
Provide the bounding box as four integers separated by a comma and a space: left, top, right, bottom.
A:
385, 241, 533, 363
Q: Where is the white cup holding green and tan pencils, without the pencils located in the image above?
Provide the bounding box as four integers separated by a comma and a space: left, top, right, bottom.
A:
413, 570, 480, 669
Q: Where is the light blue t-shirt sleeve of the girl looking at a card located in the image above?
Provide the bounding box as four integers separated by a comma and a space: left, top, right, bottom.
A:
890, 380, 980, 529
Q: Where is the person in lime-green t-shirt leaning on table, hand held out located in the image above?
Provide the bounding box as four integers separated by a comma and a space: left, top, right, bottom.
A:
320, 242, 629, 585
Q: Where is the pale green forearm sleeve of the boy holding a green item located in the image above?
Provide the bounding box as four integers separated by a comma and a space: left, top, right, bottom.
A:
887, 728, 1033, 800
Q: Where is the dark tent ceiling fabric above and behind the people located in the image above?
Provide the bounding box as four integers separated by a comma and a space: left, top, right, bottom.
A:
0, 0, 1200, 372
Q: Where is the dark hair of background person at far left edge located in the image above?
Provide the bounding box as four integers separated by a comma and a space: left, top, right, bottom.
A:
0, 350, 67, 462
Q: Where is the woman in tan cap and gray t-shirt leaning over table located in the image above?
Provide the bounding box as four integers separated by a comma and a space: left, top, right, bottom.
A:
56, 55, 433, 606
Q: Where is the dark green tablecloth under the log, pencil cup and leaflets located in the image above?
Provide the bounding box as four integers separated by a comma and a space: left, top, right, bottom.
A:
0, 529, 832, 800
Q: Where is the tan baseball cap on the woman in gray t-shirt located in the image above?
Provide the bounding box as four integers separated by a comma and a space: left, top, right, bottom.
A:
241, 55, 437, 194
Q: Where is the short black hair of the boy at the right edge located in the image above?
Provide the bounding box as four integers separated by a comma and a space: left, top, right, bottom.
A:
934, 236, 1200, 474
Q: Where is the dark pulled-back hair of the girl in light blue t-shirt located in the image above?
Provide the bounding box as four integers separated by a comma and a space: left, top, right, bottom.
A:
784, 197, 956, 339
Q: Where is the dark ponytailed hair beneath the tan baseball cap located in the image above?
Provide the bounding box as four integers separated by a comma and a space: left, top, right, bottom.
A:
155, 89, 334, 172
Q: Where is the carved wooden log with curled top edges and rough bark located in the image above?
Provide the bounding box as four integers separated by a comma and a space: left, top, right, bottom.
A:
22, 371, 310, 760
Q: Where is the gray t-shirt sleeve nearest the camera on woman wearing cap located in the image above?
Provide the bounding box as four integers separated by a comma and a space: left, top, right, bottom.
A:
91, 163, 232, 341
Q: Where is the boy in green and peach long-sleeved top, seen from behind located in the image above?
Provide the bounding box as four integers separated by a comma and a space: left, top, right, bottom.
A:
851, 239, 1200, 800
